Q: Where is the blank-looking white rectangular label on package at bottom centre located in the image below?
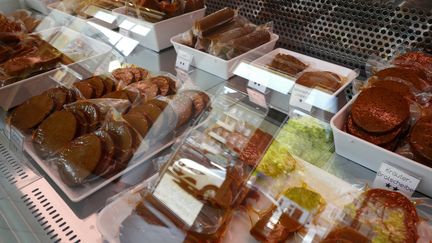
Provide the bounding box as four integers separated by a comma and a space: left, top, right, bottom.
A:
153, 173, 203, 226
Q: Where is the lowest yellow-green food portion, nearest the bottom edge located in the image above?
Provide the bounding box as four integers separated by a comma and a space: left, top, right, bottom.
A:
283, 187, 325, 212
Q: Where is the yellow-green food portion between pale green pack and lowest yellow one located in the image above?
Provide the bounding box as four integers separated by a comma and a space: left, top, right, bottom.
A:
257, 141, 296, 177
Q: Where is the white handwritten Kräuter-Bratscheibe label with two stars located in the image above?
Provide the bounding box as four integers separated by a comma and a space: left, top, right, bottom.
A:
373, 162, 421, 197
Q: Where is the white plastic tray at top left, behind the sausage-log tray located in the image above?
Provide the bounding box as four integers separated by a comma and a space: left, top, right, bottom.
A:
112, 7, 206, 51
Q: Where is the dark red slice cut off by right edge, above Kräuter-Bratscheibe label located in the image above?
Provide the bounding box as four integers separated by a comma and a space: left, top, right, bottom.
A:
409, 122, 432, 164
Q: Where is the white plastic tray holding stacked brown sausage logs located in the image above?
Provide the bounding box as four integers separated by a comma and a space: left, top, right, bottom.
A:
171, 33, 279, 79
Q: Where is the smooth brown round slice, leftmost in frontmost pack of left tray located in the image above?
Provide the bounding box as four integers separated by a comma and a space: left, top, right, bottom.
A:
33, 110, 78, 156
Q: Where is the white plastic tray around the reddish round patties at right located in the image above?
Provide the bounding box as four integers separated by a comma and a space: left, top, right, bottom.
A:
330, 96, 432, 196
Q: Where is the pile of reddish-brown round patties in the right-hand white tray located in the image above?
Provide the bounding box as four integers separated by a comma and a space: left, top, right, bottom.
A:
345, 52, 432, 166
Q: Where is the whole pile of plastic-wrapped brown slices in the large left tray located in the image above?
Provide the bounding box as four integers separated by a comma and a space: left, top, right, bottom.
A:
8, 67, 210, 187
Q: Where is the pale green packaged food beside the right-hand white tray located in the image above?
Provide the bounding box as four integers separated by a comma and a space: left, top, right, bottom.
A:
276, 117, 334, 167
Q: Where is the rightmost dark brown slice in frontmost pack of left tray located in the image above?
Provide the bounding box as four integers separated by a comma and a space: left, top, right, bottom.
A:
105, 121, 134, 164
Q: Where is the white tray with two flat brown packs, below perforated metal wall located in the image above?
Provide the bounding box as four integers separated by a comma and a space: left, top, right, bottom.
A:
252, 48, 359, 96
